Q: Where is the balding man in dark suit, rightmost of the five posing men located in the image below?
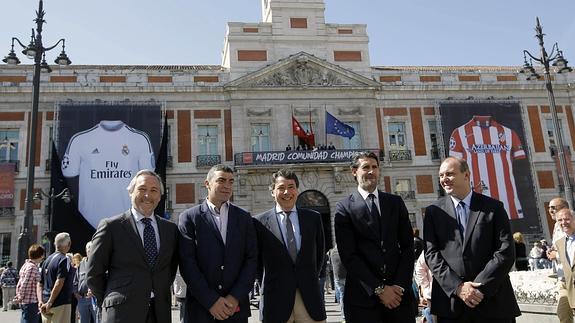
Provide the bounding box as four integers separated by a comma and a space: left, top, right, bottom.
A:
423, 157, 521, 323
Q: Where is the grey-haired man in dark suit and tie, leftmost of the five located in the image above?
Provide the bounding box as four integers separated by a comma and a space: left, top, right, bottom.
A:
87, 170, 178, 323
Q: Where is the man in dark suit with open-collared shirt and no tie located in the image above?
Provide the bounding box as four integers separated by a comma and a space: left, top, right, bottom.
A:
179, 165, 257, 323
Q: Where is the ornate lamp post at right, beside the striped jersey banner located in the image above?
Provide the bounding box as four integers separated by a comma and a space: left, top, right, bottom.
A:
521, 17, 574, 207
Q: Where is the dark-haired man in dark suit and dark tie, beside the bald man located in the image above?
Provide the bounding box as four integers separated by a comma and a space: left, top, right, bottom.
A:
335, 152, 416, 323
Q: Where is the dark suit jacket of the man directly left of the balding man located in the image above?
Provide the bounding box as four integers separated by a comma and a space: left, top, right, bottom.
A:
335, 191, 415, 321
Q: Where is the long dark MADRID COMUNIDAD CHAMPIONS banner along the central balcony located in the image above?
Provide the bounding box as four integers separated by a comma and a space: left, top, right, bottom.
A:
234, 149, 384, 165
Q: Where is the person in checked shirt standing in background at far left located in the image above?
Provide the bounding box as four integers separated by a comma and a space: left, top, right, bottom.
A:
14, 244, 44, 323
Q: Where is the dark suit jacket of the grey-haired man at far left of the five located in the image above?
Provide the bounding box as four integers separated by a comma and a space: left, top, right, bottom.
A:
87, 211, 178, 322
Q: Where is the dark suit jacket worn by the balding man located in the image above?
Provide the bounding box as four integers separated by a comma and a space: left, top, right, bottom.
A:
423, 192, 521, 321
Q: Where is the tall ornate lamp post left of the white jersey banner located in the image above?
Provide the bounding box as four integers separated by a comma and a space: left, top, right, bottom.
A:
2, 0, 72, 268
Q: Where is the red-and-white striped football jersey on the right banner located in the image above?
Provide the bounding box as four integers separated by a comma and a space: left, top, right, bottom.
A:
449, 116, 526, 219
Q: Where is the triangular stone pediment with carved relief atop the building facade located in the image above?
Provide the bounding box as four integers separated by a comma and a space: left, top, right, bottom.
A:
225, 52, 380, 88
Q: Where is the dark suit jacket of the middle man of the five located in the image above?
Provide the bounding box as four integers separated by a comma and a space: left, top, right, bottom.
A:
254, 208, 326, 322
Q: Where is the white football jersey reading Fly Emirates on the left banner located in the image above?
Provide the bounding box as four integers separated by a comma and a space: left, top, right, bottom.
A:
62, 120, 155, 228
